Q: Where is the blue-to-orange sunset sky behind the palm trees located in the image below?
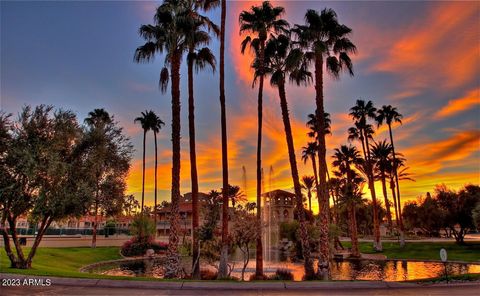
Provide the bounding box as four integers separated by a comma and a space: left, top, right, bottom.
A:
0, 1, 480, 210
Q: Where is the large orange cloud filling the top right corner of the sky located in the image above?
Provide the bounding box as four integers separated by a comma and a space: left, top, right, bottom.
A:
375, 2, 480, 91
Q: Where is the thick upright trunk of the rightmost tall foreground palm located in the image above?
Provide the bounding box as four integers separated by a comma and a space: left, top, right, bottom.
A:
315, 53, 330, 280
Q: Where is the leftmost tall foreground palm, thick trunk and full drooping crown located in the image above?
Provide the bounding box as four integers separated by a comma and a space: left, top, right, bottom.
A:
134, 0, 194, 278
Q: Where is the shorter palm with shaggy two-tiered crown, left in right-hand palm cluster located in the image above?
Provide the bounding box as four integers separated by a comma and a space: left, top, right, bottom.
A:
332, 145, 363, 257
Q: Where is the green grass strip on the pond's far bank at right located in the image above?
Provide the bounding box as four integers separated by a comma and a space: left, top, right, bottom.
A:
343, 242, 480, 263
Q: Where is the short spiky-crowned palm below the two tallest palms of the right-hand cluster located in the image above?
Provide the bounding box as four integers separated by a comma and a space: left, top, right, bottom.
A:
371, 140, 393, 232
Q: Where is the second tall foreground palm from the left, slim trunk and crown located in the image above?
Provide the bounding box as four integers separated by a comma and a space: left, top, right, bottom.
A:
186, 0, 219, 279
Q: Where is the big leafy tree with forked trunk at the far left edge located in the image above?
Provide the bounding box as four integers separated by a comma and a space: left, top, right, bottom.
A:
0, 105, 92, 269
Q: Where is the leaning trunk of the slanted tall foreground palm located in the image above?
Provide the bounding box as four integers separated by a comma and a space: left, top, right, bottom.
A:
278, 81, 315, 280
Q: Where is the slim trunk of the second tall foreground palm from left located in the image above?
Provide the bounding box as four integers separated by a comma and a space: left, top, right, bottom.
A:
188, 47, 200, 279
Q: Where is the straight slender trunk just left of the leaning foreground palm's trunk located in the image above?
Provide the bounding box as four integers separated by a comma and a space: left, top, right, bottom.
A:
255, 41, 265, 277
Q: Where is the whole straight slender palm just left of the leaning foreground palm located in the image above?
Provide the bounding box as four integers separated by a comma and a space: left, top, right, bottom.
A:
239, 1, 288, 277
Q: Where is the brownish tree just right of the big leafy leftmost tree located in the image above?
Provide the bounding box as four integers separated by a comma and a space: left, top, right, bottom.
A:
83, 109, 133, 248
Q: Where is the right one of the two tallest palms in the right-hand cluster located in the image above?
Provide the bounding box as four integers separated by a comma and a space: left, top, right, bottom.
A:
375, 105, 405, 246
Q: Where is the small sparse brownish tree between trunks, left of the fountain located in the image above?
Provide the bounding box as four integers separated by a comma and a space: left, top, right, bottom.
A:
232, 204, 260, 281
